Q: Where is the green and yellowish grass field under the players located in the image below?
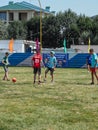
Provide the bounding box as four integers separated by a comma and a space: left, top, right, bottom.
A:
0, 67, 98, 130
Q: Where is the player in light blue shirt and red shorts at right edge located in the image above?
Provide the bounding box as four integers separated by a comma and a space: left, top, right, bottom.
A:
89, 49, 98, 84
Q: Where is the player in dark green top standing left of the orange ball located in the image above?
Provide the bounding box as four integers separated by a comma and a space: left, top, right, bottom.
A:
2, 52, 9, 81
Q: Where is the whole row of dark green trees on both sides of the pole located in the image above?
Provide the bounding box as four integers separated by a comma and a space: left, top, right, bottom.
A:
0, 9, 98, 48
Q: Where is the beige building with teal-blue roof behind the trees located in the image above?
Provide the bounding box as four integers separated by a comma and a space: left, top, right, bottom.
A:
0, 1, 54, 24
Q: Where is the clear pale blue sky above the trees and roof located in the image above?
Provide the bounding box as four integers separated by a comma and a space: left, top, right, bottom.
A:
0, 0, 98, 17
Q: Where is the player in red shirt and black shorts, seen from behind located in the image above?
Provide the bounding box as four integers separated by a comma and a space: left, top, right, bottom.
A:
31, 50, 42, 84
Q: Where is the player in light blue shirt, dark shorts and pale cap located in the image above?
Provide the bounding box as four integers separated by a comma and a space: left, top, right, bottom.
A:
45, 51, 57, 82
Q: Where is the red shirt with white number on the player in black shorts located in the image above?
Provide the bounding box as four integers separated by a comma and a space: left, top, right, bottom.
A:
32, 53, 42, 68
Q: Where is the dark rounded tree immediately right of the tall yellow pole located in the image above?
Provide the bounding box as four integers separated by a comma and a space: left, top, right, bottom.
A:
43, 15, 60, 48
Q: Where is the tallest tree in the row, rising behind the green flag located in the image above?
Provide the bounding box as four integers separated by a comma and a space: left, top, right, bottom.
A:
56, 9, 78, 47
